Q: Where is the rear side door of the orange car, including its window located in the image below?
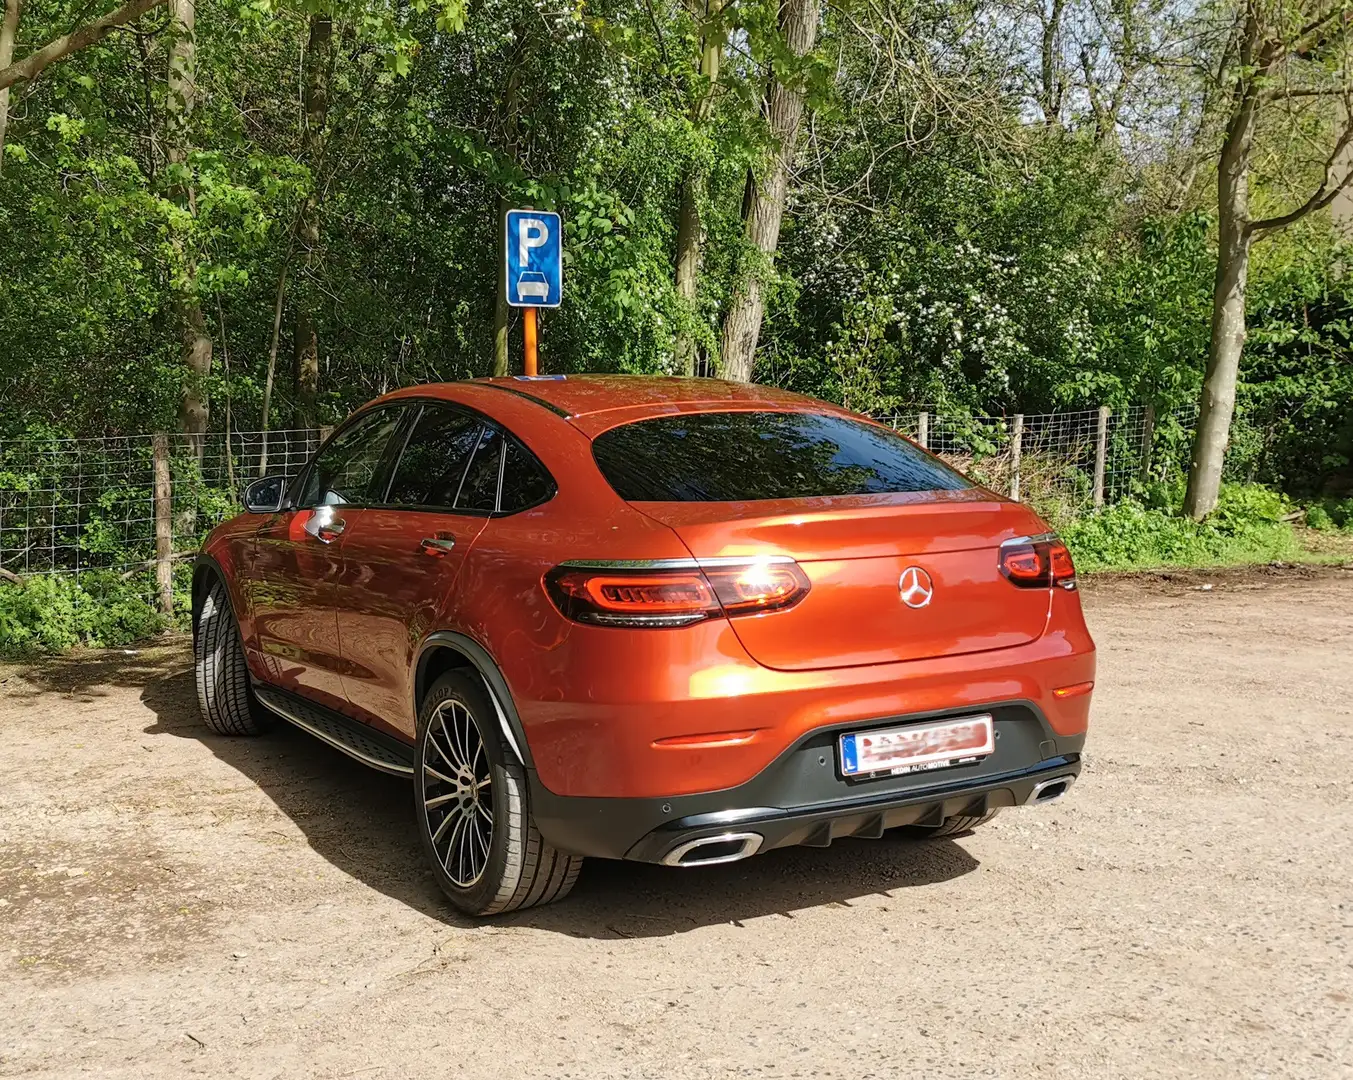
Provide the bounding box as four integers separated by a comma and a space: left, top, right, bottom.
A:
337, 402, 503, 738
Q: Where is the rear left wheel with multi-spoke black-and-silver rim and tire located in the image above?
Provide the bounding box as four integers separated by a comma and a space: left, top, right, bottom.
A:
414, 671, 583, 915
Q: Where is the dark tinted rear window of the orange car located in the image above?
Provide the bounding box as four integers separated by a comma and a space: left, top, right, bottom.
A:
593, 413, 973, 502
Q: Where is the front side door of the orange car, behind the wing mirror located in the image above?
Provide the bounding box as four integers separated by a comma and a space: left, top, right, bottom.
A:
246, 407, 403, 709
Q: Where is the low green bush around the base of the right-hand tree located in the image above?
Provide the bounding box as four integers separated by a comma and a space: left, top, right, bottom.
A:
1062, 485, 1302, 570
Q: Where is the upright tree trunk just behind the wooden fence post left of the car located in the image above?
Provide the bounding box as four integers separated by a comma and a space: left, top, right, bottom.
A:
165, 0, 211, 462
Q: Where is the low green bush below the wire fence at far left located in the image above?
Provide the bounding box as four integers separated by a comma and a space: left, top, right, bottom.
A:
0, 570, 168, 656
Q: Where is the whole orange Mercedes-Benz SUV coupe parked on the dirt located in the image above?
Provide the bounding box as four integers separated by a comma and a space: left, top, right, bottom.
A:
193, 376, 1095, 915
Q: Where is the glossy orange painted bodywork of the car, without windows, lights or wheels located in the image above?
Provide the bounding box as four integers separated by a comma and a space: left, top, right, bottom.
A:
207, 376, 1095, 797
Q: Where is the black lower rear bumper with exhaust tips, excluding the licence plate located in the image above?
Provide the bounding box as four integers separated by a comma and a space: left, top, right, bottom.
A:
532, 701, 1085, 862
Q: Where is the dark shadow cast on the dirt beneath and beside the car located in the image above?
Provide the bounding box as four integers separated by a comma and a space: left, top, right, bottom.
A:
141, 671, 978, 938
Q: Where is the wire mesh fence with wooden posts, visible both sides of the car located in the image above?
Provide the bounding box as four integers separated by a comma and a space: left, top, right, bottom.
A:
0, 406, 1196, 592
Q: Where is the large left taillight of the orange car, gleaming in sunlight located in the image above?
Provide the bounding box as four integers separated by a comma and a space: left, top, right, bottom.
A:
545, 559, 810, 627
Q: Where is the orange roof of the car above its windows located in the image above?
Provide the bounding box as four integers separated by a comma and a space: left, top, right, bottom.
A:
382, 375, 844, 437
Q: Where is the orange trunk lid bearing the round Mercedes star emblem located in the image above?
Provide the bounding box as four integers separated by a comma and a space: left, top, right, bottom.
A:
633, 489, 1051, 671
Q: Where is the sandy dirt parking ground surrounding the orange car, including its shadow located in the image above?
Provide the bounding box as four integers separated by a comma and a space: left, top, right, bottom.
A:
0, 570, 1353, 1080
